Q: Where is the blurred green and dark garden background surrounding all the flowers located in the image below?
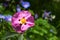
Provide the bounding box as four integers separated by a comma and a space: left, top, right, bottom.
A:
0, 0, 60, 40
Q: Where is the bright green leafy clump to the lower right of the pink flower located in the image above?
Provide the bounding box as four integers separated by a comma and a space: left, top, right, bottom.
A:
24, 18, 57, 40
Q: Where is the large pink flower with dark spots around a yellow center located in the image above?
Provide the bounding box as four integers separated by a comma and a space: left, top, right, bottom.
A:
11, 10, 34, 33
